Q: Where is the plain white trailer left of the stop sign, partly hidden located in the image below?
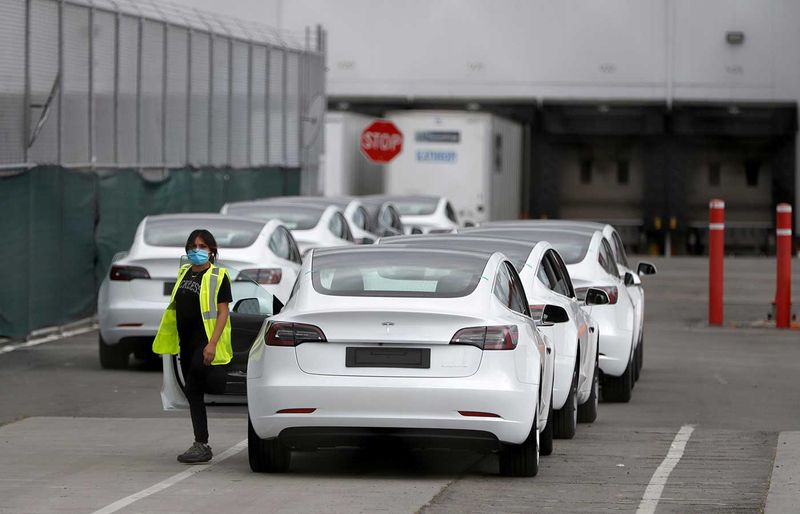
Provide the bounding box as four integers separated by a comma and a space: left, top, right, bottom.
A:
319, 111, 383, 196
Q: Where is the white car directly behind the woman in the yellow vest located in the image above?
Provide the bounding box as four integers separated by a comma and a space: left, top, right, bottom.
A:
97, 213, 301, 368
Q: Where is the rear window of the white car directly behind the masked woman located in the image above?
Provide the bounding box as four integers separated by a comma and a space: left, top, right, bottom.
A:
144, 216, 264, 248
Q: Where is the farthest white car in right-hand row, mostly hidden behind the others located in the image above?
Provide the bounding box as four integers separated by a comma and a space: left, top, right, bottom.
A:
488, 220, 656, 380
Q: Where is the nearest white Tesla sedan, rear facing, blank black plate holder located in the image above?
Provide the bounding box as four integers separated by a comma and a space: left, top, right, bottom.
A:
247, 246, 553, 476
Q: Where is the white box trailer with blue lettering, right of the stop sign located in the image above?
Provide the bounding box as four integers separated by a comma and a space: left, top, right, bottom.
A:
385, 111, 522, 225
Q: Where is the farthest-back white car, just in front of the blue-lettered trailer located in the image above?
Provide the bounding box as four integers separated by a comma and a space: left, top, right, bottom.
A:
368, 196, 459, 234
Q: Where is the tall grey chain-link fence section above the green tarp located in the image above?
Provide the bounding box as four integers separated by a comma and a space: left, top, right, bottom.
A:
0, 0, 325, 177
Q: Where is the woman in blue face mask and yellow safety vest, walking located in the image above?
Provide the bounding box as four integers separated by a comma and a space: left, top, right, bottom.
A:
153, 229, 233, 464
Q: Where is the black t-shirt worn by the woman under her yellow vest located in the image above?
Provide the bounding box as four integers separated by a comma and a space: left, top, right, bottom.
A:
175, 268, 233, 350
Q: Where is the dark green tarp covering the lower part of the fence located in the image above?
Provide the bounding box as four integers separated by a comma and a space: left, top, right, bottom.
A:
0, 166, 300, 338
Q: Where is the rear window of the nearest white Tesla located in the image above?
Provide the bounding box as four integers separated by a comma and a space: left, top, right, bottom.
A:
311, 249, 488, 298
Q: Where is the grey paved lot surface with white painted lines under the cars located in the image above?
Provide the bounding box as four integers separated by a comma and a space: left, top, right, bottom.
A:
0, 258, 800, 513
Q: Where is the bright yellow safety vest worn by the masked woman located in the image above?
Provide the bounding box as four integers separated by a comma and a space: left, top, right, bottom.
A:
153, 264, 233, 365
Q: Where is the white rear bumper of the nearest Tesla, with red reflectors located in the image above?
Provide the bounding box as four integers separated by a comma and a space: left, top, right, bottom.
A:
247, 351, 539, 444
